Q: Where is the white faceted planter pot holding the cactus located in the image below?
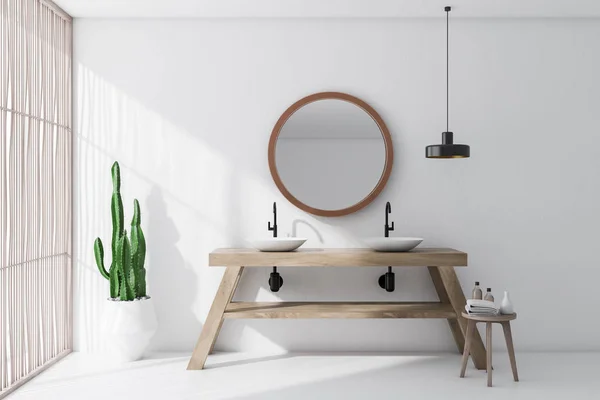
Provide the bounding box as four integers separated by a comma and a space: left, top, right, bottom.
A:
101, 298, 158, 362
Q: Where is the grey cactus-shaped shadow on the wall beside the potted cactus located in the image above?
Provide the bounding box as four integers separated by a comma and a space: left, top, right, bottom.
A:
146, 186, 202, 350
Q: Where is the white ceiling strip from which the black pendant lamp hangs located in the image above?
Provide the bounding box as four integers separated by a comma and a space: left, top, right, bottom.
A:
54, 0, 600, 18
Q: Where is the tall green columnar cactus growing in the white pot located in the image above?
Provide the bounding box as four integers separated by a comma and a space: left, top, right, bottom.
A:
94, 161, 147, 301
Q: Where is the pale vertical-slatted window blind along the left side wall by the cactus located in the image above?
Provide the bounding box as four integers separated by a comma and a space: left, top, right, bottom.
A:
0, 0, 72, 398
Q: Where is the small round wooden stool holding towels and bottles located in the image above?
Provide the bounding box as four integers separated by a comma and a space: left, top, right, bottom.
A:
460, 312, 519, 387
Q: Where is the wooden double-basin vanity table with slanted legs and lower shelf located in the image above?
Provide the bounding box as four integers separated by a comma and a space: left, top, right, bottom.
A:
188, 248, 486, 370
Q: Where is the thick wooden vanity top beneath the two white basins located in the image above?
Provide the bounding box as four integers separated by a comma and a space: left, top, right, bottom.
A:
209, 247, 467, 267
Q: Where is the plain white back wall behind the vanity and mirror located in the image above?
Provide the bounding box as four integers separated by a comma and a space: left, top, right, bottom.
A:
75, 19, 600, 351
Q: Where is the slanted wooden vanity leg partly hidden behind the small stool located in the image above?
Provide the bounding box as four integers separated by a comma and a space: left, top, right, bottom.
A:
428, 267, 486, 370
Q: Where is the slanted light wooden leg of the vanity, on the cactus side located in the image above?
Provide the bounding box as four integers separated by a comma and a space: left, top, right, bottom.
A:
187, 267, 244, 370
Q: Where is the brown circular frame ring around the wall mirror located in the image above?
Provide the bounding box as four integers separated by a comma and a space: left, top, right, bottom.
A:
269, 92, 394, 217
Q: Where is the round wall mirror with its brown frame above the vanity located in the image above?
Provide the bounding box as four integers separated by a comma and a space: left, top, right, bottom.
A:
269, 92, 394, 217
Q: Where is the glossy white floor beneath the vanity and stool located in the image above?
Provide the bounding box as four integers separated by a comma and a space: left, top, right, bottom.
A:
8, 353, 600, 400
